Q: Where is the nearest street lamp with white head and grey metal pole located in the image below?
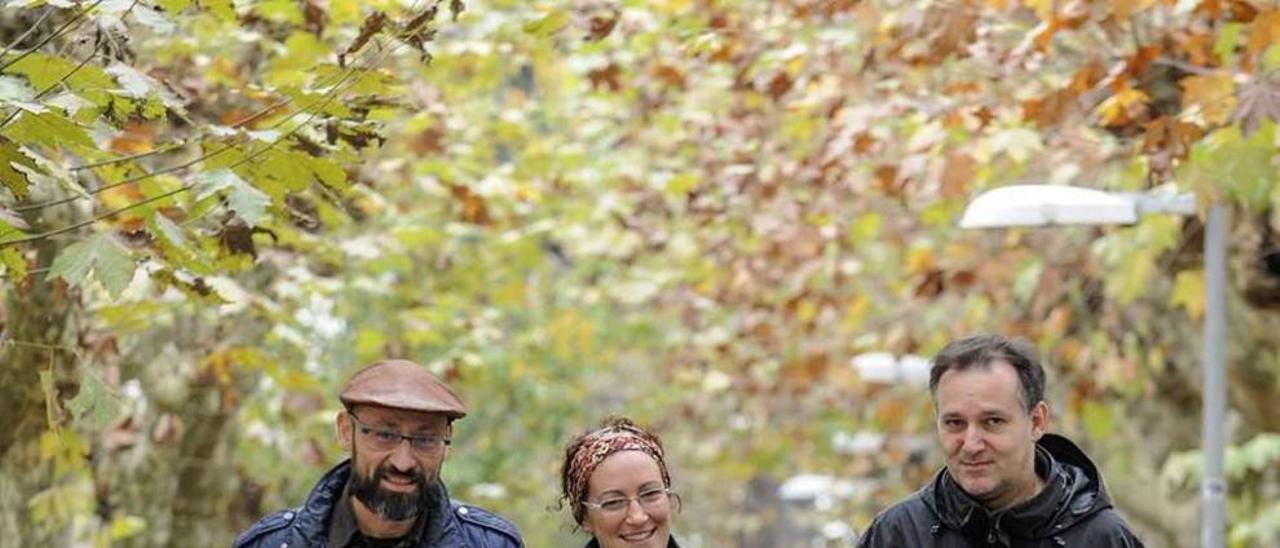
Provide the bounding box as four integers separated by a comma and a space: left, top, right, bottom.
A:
960, 184, 1226, 548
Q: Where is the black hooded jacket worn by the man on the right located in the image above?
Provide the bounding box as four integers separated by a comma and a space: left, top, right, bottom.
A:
858, 434, 1143, 548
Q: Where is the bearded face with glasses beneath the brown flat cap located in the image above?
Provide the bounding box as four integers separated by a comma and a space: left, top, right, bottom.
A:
337, 406, 451, 521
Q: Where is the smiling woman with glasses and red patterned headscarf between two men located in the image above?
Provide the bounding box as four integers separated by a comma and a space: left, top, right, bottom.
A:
561, 419, 680, 548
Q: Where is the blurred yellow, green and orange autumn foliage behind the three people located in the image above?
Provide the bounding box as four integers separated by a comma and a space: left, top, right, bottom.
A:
0, 0, 1280, 547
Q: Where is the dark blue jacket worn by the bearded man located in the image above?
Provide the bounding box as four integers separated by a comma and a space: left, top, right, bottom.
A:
234, 461, 525, 548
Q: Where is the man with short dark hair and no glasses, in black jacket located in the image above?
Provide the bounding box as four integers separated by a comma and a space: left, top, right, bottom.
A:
859, 335, 1143, 548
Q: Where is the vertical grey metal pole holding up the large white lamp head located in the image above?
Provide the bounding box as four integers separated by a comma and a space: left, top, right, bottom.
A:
1201, 205, 1226, 548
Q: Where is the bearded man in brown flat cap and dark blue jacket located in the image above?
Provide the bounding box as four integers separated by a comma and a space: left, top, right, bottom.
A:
236, 360, 524, 548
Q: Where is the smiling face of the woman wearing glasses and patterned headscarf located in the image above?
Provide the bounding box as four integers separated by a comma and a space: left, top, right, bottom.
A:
582, 451, 671, 548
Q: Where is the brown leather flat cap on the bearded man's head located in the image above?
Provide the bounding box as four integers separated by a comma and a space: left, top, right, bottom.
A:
338, 360, 467, 419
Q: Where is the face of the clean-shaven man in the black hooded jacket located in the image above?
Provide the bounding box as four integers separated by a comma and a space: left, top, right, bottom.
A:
936, 360, 1048, 510
